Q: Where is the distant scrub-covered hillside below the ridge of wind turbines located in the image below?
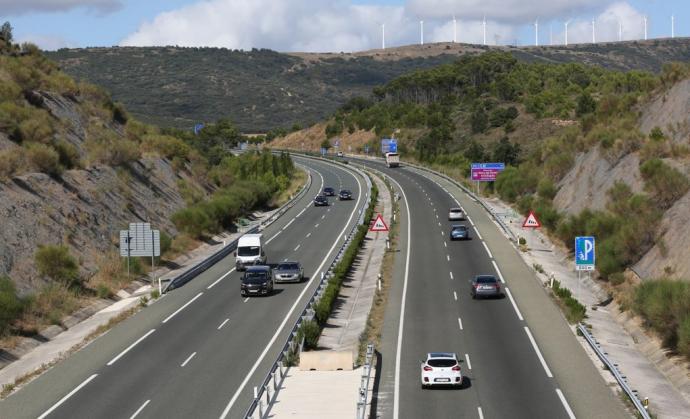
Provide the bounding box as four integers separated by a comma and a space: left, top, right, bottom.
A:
47, 38, 690, 132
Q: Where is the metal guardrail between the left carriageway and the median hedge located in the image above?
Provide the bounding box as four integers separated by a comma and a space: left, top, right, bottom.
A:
244, 154, 372, 419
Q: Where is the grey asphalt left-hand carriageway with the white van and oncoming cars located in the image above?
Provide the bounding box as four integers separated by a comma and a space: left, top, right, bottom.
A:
0, 158, 368, 419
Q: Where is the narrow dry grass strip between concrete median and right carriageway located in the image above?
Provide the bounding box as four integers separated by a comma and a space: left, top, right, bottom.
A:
357, 174, 400, 365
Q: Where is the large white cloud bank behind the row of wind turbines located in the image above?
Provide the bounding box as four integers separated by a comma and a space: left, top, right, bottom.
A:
122, 0, 641, 52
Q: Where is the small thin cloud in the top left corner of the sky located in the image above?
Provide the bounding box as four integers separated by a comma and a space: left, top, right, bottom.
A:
0, 0, 122, 16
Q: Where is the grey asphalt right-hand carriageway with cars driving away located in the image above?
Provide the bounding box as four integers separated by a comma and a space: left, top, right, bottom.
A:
352, 157, 625, 419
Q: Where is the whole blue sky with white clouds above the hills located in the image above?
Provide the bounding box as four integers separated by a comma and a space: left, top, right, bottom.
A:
0, 0, 690, 52
